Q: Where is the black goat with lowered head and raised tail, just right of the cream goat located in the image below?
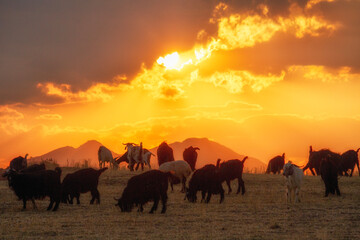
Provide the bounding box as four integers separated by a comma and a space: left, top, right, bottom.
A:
185, 159, 224, 203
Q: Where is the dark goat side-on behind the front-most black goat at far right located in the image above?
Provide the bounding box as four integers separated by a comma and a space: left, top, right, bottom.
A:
303, 146, 342, 176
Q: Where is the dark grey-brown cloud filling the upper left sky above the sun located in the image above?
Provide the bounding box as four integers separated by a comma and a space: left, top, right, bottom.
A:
0, 0, 216, 104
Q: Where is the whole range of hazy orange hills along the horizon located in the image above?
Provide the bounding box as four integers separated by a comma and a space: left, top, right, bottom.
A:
30, 138, 266, 171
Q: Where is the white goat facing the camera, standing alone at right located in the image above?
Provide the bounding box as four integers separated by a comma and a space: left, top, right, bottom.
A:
283, 161, 304, 203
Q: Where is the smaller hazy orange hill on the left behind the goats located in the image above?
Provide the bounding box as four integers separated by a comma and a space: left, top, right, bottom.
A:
29, 140, 119, 167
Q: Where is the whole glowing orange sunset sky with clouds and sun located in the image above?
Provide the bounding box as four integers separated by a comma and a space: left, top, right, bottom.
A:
0, 0, 360, 167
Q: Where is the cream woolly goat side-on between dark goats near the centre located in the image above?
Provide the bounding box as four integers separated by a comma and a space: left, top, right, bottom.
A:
159, 160, 192, 192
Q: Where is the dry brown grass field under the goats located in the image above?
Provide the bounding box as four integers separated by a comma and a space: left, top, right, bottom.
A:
0, 169, 360, 239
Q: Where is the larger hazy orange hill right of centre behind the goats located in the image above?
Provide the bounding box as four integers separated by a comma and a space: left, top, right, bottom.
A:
150, 138, 266, 172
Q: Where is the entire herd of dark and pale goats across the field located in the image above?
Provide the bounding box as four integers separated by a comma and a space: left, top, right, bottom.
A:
3, 142, 360, 213
